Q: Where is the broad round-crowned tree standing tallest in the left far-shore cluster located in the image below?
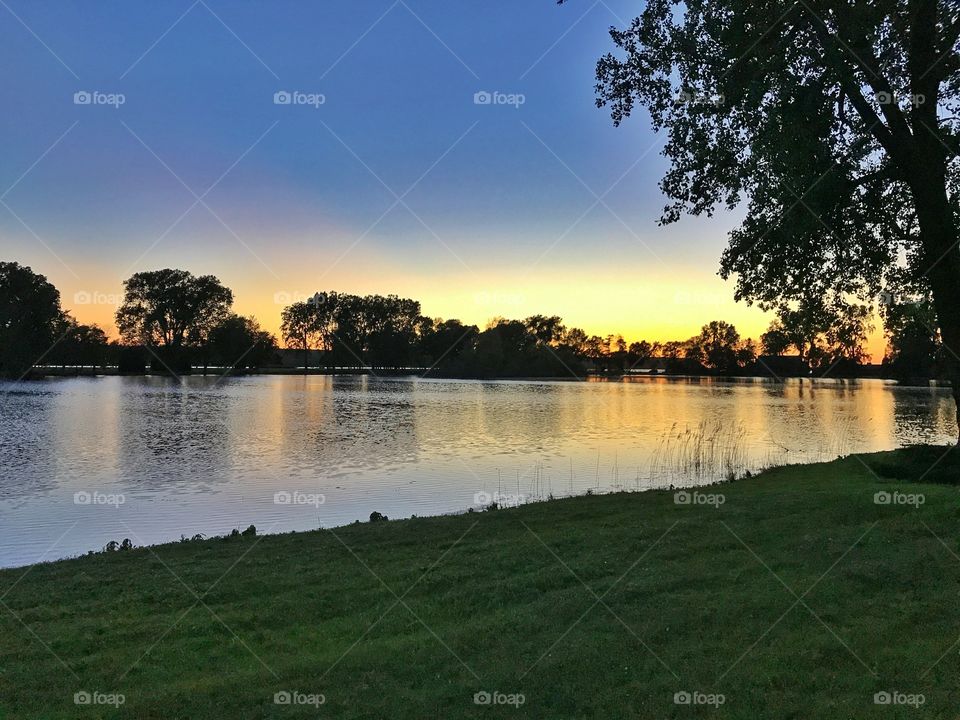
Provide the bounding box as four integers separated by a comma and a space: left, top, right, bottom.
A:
116, 269, 233, 368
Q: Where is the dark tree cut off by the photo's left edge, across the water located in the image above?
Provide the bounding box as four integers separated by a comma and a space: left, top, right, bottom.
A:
0, 262, 66, 378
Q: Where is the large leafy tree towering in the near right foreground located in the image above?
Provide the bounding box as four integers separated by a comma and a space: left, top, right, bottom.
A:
561, 0, 960, 438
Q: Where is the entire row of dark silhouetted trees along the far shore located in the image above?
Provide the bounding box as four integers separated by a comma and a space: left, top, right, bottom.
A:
0, 262, 946, 380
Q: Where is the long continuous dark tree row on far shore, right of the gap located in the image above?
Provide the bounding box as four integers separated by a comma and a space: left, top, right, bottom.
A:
281, 293, 892, 377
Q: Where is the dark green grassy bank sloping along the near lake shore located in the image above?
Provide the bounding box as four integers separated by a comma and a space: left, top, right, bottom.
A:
0, 448, 960, 720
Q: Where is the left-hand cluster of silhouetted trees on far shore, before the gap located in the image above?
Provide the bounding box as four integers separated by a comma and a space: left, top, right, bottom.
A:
0, 262, 277, 378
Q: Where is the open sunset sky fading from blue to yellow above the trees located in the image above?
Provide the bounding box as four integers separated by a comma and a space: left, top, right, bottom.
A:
0, 0, 882, 352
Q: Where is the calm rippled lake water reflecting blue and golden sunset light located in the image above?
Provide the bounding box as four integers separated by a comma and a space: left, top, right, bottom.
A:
0, 376, 956, 566
